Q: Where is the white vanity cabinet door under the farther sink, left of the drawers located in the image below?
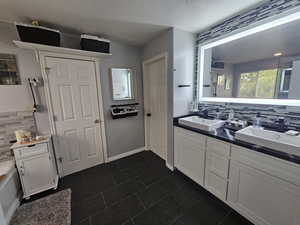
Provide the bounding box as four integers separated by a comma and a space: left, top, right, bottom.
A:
174, 128, 206, 185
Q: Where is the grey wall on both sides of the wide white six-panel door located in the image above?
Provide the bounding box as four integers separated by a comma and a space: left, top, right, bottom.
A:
0, 22, 144, 157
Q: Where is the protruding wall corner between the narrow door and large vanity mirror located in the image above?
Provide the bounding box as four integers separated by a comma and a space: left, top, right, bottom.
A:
142, 28, 195, 166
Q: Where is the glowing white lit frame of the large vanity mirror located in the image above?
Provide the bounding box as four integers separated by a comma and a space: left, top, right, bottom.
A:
197, 9, 300, 106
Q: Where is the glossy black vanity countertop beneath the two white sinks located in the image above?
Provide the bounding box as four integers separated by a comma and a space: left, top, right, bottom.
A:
173, 115, 300, 164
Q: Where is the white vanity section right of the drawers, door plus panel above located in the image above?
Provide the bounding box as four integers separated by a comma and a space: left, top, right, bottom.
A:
228, 145, 300, 225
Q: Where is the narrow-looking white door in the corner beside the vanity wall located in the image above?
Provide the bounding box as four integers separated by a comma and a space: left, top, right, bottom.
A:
144, 56, 167, 159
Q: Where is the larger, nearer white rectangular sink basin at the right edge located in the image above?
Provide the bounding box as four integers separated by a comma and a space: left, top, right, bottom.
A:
235, 126, 300, 156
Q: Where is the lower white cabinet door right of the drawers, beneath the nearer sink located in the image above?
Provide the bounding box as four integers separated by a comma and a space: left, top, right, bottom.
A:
227, 161, 300, 225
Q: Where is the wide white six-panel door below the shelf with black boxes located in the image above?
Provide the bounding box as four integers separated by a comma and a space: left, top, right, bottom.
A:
45, 57, 104, 175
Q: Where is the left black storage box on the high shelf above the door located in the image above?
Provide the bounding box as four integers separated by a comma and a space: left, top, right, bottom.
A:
15, 23, 60, 47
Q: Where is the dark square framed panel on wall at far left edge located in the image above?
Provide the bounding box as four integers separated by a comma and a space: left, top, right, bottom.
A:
0, 53, 21, 85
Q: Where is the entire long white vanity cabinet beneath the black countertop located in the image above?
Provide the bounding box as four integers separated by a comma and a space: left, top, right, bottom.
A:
174, 127, 300, 225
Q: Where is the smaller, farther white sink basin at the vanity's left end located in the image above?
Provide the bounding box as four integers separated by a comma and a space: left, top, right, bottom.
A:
179, 116, 225, 131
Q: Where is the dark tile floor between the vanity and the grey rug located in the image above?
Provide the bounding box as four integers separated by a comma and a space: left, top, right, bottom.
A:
27, 152, 251, 225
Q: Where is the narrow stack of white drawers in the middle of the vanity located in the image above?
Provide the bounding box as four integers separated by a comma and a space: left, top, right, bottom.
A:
204, 137, 230, 200
